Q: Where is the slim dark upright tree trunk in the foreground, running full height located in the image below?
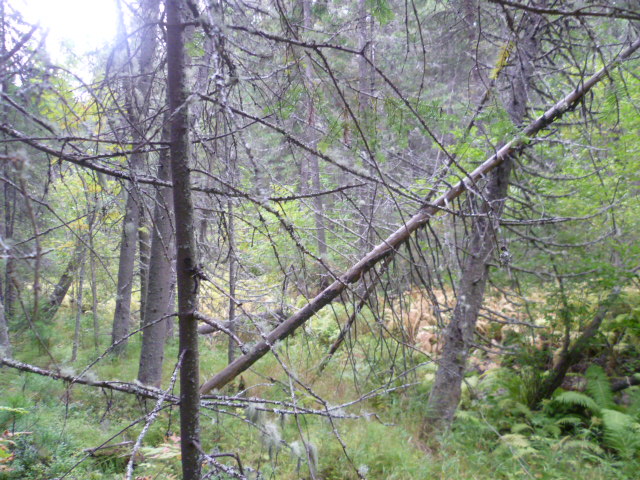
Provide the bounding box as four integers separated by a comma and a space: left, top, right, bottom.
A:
165, 0, 201, 480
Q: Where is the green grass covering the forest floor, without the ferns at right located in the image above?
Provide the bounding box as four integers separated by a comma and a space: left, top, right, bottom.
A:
0, 306, 639, 480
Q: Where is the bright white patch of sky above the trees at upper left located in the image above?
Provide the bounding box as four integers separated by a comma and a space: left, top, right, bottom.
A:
16, 0, 117, 56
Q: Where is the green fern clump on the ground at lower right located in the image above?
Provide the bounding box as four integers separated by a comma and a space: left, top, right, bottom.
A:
456, 365, 640, 478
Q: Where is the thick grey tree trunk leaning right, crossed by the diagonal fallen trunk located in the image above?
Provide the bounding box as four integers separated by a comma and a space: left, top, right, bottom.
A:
425, 5, 540, 433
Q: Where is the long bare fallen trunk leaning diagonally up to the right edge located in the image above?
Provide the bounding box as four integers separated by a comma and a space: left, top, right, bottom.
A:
200, 39, 640, 394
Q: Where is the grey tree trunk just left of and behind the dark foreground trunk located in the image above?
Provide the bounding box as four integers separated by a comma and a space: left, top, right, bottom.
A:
138, 120, 175, 387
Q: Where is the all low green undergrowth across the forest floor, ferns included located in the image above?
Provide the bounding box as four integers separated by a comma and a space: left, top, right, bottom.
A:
0, 306, 640, 480
